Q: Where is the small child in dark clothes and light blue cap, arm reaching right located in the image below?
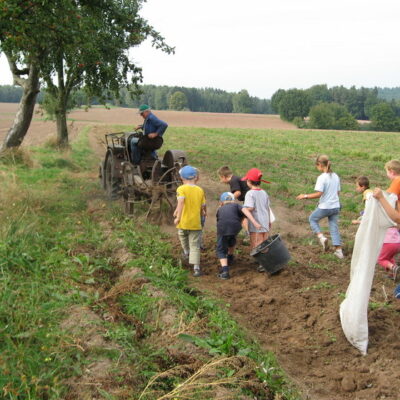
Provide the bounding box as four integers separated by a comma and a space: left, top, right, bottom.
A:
217, 192, 261, 279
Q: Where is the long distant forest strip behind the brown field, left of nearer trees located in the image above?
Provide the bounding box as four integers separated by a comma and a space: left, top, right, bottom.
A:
0, 85, 272, 114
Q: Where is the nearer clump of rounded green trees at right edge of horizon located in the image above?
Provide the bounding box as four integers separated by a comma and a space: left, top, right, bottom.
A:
271, 85, 400, 132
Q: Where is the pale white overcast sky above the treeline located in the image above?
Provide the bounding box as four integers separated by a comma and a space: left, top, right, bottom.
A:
0, 0, 400, 99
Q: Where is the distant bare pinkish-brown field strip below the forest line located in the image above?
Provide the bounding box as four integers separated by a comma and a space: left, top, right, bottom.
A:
0, 103, 296, 145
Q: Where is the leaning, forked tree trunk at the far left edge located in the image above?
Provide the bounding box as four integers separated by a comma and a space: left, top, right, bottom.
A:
0, 60, 40, 153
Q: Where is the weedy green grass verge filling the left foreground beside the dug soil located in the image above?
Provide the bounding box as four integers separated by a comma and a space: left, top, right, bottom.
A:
0, 129, 299, 400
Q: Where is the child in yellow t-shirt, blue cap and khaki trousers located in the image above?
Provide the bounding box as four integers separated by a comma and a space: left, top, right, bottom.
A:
174, 165, 207, 277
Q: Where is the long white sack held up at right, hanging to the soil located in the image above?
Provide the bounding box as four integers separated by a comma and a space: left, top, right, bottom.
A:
340, 192, 397, 355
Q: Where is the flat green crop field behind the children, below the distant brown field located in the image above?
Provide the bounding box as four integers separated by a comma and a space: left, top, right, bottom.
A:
108, 126, 398, 226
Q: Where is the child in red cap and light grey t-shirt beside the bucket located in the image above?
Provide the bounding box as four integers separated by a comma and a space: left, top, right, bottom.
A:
242, 168, 271, 272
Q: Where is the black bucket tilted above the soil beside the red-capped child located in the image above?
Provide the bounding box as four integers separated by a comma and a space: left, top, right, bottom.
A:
250, 235, 290, 275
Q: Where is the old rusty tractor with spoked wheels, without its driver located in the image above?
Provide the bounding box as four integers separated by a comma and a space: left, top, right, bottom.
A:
99, 131, 187, 219
